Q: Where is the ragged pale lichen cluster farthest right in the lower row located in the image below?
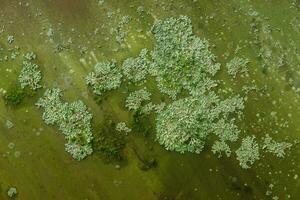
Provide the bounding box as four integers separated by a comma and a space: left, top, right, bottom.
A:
262, 134, 293, 158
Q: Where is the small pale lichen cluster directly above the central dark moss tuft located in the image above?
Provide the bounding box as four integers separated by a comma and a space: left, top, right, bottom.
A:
125, 88, 151, 111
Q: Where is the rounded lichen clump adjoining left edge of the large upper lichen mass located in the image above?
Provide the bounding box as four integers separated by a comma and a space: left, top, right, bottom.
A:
122, 49, 150, 83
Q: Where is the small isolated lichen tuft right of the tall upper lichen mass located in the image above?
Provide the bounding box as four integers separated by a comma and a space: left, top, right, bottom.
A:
226, 57, 250, 78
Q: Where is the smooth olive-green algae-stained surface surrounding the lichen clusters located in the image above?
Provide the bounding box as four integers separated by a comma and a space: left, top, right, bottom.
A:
0, 0, 300, 200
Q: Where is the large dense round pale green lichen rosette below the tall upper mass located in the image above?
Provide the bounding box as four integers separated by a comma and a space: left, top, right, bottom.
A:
156, 98, 209, 153
